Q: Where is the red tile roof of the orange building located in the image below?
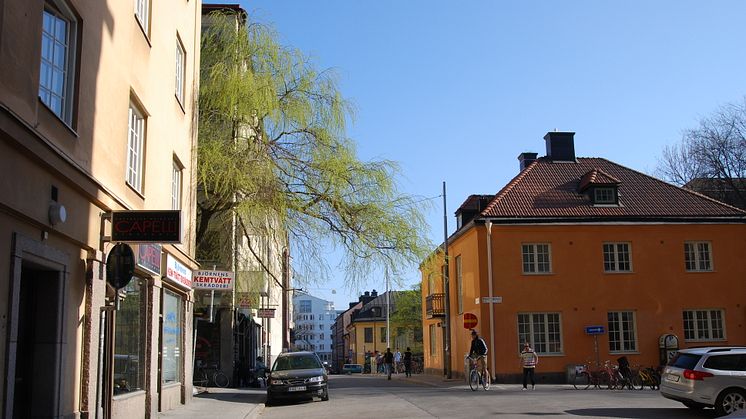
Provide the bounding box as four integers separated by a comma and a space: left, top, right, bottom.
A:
481, 157, 746, 220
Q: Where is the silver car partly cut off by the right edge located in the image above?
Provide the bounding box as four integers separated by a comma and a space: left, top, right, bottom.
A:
660, 347, 746, 415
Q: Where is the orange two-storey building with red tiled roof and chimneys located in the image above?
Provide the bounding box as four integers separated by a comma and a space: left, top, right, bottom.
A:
422, 132, 746, 382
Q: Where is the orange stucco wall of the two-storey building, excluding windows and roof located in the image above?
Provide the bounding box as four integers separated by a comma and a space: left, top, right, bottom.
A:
423, 224, 746, 378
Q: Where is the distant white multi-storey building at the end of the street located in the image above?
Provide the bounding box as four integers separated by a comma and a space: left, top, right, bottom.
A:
293, 292, 337, 361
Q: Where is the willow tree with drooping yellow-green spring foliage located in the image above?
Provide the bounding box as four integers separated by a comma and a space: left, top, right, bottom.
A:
197, 12, 430, 286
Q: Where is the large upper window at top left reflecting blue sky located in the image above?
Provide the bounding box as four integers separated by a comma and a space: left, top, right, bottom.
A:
39, 1, 77, 125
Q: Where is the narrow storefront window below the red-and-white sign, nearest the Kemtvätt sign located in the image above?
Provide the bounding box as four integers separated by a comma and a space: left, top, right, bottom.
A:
161, 289, 182, 384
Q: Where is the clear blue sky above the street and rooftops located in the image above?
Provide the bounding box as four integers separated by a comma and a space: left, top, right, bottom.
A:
206, 0, 746, 309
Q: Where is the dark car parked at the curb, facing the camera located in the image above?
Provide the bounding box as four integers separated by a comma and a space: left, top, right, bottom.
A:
265, 352, 329, 406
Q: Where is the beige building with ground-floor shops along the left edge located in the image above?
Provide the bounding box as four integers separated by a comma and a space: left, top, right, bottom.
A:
0, 0, 201, 418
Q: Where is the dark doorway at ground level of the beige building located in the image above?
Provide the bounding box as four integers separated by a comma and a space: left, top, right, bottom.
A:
13, 263, 62, 418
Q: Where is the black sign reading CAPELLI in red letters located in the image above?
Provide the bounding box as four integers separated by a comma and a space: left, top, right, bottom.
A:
111, 210, 181, 243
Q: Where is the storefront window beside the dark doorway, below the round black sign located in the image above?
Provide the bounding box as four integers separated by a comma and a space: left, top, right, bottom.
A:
114, 278, 147, 395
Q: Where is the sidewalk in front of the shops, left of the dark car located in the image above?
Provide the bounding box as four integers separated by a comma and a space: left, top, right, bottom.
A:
158, 387, 267, 419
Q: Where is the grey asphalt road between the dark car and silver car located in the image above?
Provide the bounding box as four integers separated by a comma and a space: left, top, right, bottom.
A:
260, 375, 715, 419
